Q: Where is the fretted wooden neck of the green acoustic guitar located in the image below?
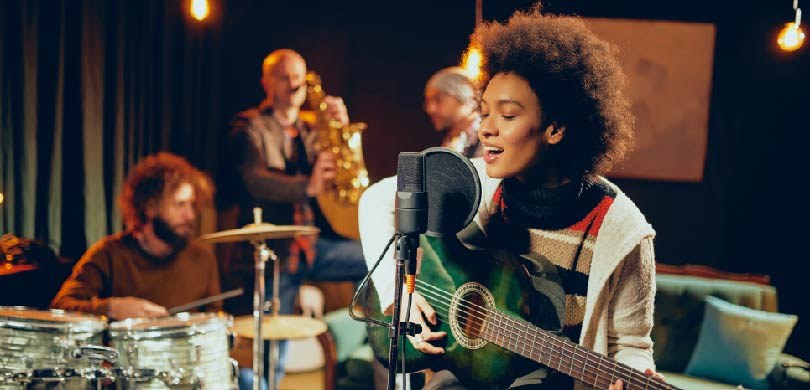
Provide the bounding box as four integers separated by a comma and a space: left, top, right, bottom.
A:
480, 311, 677, 390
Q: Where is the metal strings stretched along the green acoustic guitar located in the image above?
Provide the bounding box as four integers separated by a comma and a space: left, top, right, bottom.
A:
417, 279, 669, 388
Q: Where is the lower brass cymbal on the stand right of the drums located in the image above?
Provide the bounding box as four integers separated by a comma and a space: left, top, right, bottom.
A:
233, 315, 326, 340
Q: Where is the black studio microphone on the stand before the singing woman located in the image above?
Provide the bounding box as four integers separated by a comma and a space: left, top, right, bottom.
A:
394, 152, 429, 293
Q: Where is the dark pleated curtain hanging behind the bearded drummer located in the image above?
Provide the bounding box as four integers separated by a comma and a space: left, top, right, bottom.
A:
0, 0, 221, 258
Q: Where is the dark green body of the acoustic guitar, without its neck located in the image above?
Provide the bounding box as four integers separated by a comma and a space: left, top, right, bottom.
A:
367, 235, 561, 388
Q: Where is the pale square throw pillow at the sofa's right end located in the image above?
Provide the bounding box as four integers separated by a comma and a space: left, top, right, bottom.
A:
686, 297, 797, 389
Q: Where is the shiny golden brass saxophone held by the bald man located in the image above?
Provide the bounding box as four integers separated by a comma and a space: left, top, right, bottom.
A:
306, 71, 369, 239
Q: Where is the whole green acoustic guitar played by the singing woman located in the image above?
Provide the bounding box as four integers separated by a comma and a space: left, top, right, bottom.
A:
366, 235, 676, 389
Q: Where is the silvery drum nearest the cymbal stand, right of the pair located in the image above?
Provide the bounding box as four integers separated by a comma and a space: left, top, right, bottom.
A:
109, 313, 236, 390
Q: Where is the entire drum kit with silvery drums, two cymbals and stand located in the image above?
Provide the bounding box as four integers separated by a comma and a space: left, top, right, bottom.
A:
0, 209, 326, 390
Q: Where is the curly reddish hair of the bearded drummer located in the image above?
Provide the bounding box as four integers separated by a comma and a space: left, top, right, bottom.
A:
118, 152, 214, 229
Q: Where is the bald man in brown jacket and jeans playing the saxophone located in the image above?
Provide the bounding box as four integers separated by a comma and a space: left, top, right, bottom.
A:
230, 49, 366, 388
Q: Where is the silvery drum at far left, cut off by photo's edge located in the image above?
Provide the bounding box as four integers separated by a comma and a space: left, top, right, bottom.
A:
0, 306, 107, 389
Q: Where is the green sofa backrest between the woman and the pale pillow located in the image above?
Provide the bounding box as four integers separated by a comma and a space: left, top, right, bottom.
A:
651, 275, 776, 372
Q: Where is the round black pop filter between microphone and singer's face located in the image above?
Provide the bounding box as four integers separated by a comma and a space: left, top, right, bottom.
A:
422, 148, 481, 237
